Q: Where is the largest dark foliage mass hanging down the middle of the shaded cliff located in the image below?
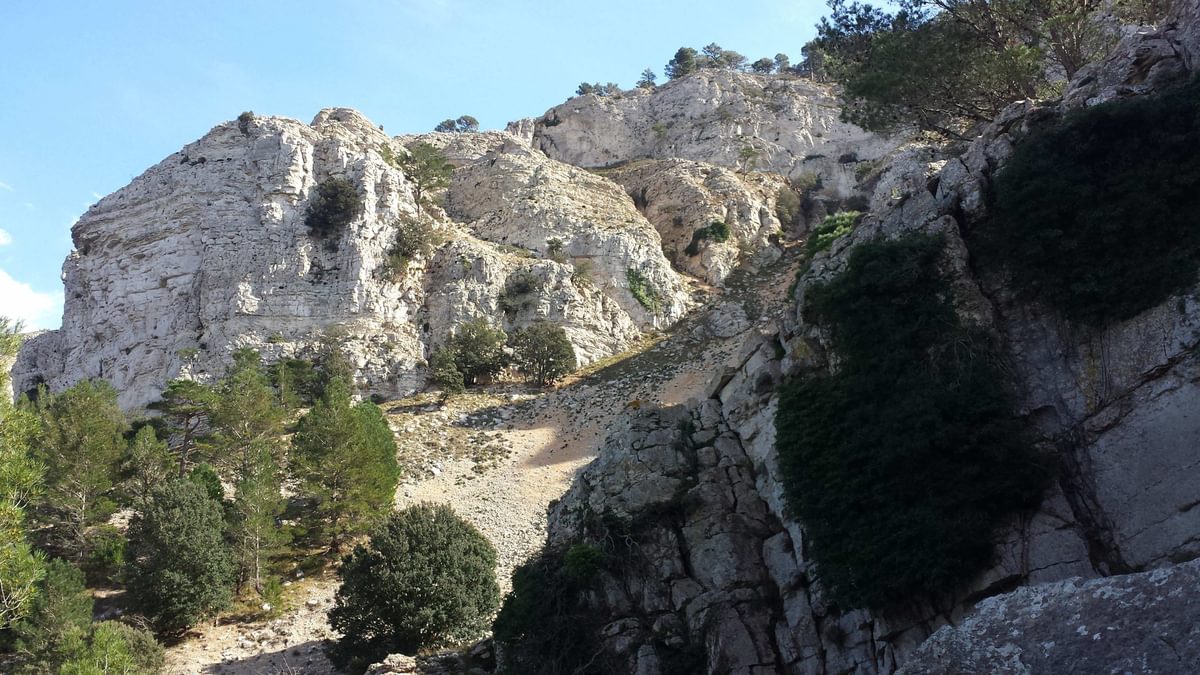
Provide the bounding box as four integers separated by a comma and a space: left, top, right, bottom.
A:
775, 234, 1045, 609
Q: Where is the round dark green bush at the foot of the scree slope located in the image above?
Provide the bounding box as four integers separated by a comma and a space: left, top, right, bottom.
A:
329, 503, 500, 665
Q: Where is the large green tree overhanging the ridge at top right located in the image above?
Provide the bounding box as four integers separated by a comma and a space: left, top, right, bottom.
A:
806, 0, 1122, 137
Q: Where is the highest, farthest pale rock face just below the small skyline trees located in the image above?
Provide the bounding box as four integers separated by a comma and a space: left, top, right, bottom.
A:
533, 70, 898, 197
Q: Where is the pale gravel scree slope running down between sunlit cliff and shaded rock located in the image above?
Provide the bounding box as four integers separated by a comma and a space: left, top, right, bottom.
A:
159, 249, 794, 675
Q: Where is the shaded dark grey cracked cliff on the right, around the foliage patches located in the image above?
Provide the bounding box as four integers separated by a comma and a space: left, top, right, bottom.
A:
539, 4, 1200, 674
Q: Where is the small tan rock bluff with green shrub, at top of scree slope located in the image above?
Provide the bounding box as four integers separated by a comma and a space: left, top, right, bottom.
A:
605, 160, 791, 286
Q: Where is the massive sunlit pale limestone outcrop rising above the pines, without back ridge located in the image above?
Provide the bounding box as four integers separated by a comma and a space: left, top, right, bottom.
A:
12, 109, 689, 408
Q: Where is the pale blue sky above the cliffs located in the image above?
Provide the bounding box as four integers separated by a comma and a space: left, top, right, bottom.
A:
0, 0, 826, 328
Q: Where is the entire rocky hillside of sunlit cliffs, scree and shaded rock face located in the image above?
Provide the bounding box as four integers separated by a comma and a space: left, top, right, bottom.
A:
12, 2, 1200, 675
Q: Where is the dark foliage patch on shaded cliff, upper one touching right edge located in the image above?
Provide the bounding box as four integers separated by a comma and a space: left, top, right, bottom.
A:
968, 80, 1200, 325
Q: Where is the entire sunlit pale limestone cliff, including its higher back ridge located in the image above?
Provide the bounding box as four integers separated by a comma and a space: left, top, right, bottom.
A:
12, 72, 873, 407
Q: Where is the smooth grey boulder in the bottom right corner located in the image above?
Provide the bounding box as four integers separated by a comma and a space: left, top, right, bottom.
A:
900, 562, 1200, 675
